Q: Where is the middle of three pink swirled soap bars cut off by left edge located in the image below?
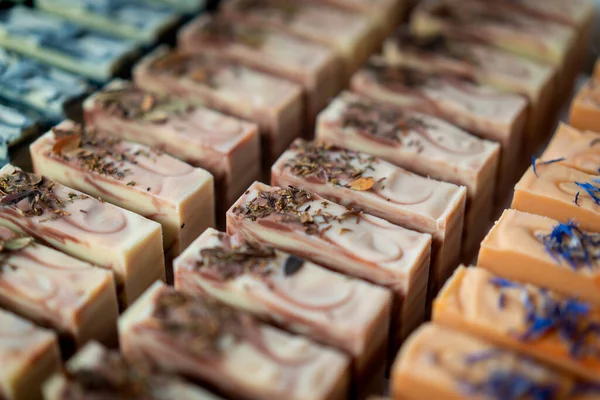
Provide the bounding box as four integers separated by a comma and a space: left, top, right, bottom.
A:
0, 227, 119, 347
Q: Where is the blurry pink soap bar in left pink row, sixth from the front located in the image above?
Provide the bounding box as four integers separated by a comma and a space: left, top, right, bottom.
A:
134, 48, 305, 166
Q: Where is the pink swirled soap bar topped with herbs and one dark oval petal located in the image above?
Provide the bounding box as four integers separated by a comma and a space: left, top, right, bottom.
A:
174, 229, 391, 397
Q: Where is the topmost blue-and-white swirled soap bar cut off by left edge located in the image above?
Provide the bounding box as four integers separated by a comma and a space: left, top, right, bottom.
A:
0, 6, 137, 81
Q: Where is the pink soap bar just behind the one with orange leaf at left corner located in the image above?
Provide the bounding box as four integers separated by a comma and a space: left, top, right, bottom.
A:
83, 80, 260, 208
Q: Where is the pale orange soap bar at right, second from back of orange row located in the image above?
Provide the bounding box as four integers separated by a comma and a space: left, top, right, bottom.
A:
539, 124, 600, 175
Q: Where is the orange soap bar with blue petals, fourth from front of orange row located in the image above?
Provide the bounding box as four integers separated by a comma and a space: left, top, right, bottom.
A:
511, 163, 600, 232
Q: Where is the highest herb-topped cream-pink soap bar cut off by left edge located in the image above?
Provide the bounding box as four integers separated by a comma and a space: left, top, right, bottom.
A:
0, 164, 165, 306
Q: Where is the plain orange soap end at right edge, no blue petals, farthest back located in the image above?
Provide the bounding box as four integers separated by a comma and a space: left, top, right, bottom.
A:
569, 79, 600, 132
